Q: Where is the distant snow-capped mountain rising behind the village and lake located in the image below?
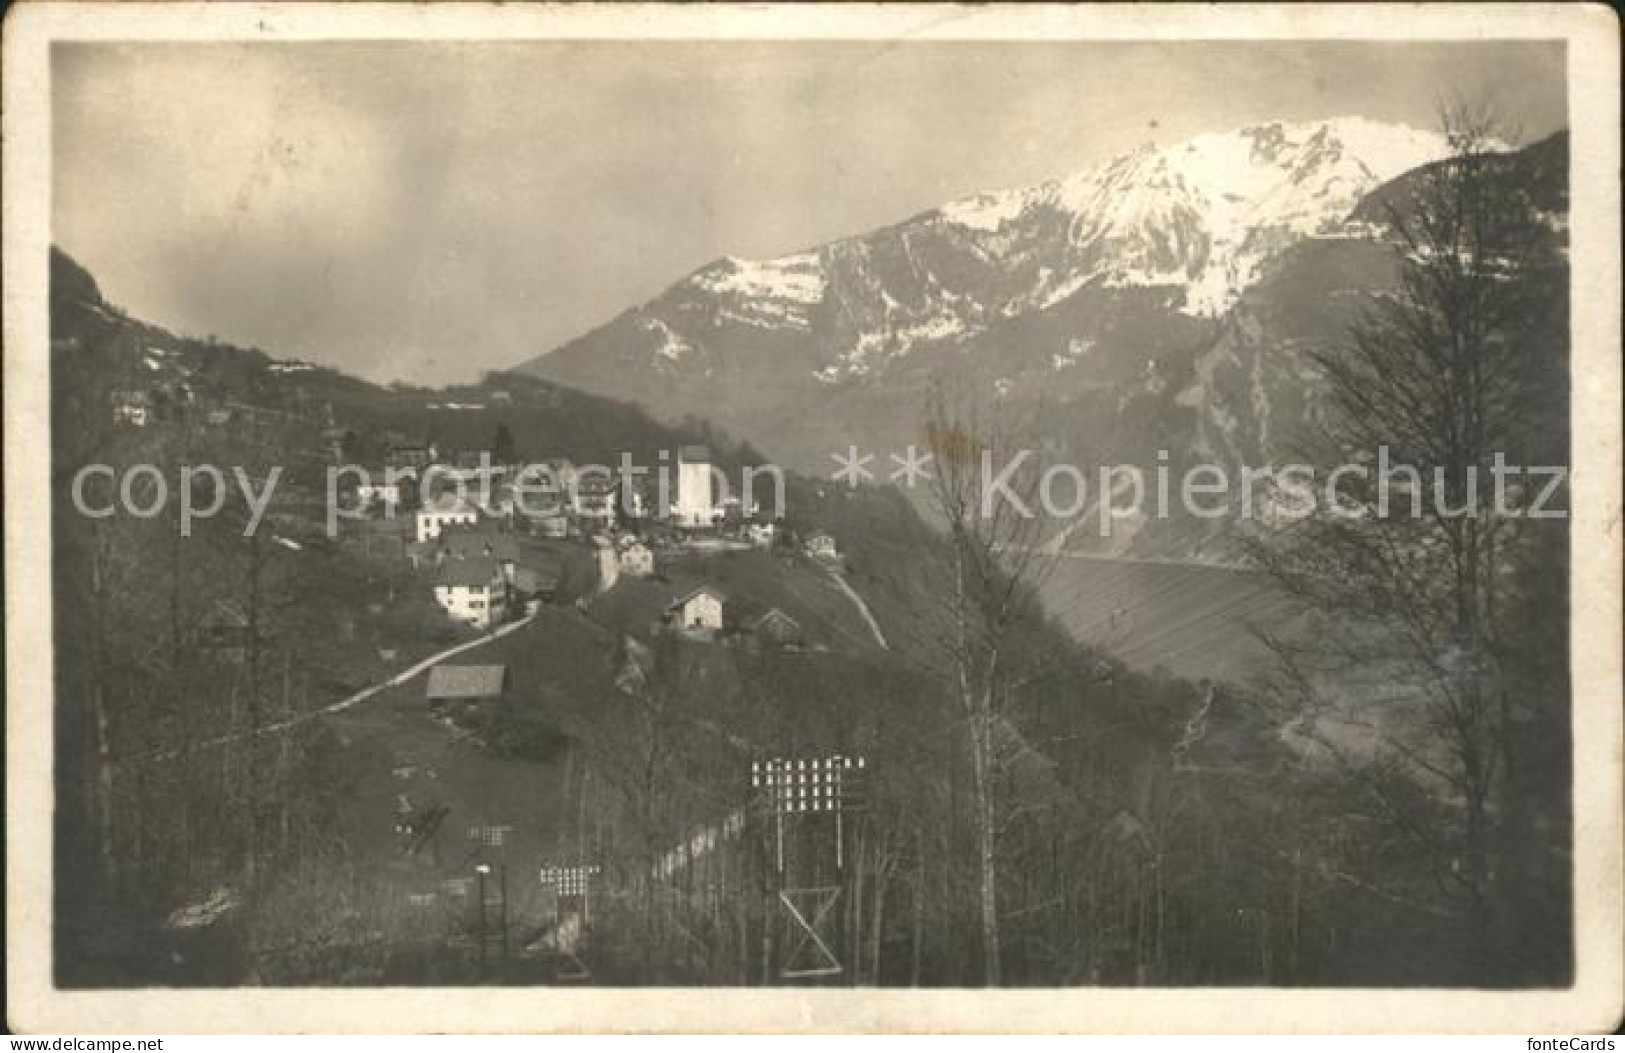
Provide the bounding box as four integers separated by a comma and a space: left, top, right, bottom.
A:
525, 119, 1567, 559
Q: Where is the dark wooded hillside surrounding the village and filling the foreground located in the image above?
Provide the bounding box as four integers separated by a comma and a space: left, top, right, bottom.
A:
52, 232, 1567, 986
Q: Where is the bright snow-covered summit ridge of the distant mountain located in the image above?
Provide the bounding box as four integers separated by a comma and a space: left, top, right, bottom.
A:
666, 115, 1448, 331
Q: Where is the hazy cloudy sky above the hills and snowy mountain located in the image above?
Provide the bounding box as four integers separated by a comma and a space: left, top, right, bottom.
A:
52, 42, 1567, 384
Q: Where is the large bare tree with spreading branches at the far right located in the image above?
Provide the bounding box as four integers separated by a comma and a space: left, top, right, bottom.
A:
1255, 106, 1562, 975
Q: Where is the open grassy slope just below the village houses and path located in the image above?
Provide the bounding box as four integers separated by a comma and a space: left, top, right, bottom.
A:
281, 542, 878, 982
